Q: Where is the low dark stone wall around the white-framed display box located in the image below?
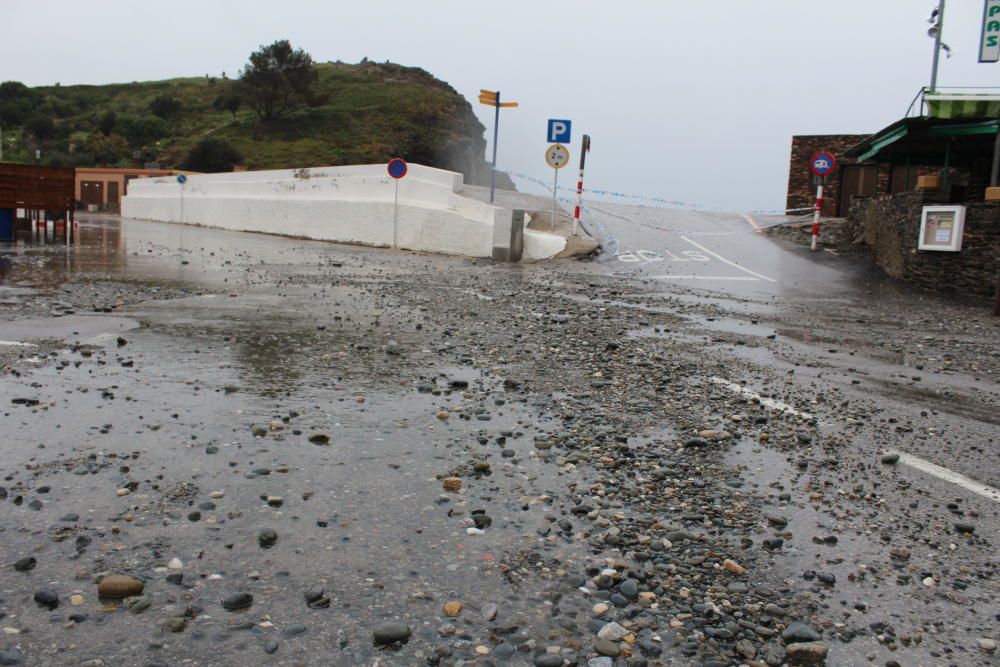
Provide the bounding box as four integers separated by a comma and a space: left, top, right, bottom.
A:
845, 191, 1000, 297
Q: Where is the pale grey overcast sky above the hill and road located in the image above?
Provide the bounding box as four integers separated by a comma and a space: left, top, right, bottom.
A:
0, 0, 1000, 209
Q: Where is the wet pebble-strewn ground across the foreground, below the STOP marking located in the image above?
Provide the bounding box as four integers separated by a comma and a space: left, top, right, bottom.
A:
0, 219, 1000, 666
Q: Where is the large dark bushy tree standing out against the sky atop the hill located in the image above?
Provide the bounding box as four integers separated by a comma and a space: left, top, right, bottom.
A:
240, 39, 319, 122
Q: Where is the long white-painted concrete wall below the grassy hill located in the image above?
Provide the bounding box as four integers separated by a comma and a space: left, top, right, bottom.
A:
122, 164, 566, 259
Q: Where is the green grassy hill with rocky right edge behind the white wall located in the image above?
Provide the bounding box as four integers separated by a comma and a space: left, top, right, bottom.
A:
0, 61, 500, 184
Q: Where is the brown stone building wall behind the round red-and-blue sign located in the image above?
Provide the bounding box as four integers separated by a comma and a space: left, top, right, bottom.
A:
785, 134, 872, 217
